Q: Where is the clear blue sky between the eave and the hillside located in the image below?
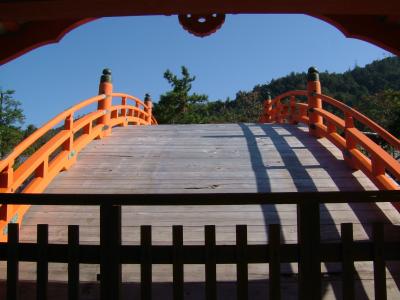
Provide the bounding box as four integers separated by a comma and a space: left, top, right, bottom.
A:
0, 15, 389, 126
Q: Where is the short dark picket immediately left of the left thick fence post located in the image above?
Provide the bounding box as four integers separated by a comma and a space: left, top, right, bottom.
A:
68, 225, 80, 300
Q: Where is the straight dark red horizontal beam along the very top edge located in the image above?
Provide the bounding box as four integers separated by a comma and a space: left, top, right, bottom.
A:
0, 0, 400, 22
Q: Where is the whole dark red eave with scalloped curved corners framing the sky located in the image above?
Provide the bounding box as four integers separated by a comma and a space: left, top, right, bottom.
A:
0, 0, 400, 64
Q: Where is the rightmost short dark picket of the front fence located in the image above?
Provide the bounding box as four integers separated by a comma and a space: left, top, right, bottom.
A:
372, 223, 387, 300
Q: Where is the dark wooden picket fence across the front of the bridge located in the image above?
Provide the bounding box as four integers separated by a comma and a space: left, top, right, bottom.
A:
0, 191, 400, 300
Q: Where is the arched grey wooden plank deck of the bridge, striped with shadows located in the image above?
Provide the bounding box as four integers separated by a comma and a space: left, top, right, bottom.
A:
1, 124, 400, 299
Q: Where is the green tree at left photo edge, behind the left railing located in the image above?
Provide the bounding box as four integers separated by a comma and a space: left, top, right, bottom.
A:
0, 89, 25, 159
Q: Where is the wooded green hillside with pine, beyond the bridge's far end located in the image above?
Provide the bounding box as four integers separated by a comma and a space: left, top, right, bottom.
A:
154, 57, 400, 135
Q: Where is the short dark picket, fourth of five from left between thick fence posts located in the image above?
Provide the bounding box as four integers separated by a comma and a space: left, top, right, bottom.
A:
236, 225, 249, 300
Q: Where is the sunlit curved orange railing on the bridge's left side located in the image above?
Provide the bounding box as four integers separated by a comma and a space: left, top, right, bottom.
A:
0, 69, 157, 241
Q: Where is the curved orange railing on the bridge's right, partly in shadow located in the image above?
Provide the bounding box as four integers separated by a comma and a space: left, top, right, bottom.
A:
260, 68, 400, 190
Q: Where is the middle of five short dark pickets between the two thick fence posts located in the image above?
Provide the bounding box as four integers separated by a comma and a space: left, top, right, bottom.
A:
204, 225, 217, 300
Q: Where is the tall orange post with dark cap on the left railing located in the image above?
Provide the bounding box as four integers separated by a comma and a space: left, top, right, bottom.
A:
97, 69, 113, 137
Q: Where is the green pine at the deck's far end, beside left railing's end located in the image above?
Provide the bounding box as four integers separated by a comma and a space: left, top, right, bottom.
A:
154, 66, 208, 124
